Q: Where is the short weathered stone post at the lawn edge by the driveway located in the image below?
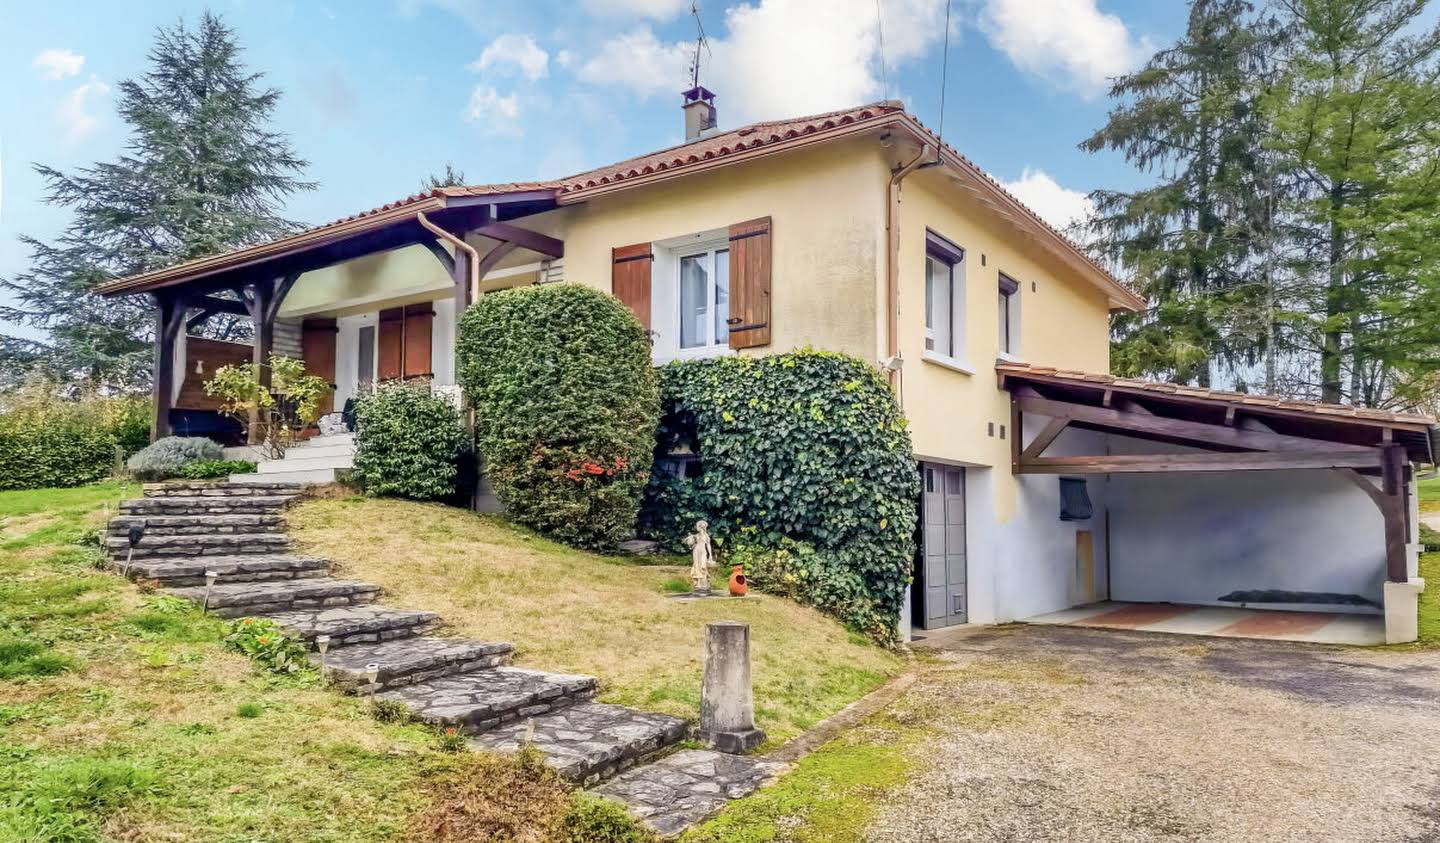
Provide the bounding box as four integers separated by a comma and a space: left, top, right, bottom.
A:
700, 621, 765, 755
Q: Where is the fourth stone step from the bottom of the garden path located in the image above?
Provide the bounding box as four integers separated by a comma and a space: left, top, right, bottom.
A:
310, 638, 516, 693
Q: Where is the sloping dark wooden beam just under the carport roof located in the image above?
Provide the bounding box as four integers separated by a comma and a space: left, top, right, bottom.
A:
1014, 395, 1378, 452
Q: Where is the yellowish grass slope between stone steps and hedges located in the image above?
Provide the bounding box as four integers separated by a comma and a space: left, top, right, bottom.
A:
289, 497, 901, 741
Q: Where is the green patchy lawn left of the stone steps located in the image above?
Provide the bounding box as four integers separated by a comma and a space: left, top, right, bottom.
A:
0, 486, 619, 843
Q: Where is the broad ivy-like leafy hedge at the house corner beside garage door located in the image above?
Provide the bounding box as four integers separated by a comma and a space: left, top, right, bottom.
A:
642, 350, 920, 641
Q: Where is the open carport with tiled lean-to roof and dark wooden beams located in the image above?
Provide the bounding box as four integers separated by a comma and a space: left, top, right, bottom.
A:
996, 362, 1434, 643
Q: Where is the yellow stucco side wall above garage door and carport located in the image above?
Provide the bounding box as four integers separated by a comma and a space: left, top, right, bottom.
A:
900, 162, 1110, 522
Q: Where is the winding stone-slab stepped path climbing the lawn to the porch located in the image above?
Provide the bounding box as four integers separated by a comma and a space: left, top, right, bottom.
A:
105, 481, 786, 836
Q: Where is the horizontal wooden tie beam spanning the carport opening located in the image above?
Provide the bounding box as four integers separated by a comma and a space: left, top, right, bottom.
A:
1020, 450, 1381, 474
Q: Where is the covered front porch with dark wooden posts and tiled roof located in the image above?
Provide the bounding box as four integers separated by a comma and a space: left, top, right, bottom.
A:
98, 184, 564, 440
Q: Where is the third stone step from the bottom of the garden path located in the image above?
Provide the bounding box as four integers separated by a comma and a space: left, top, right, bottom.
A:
376, 667, 595, 735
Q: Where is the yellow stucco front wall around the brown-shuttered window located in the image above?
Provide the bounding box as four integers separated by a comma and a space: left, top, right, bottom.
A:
520, 140, 888, 360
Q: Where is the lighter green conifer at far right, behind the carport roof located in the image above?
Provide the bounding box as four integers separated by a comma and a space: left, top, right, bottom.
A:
1266, 0, 1440, 405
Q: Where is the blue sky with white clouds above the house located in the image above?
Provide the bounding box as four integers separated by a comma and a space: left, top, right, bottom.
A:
0, 0, 1185, 335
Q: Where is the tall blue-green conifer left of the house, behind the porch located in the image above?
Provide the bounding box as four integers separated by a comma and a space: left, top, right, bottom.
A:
0, 13, 314, 389
